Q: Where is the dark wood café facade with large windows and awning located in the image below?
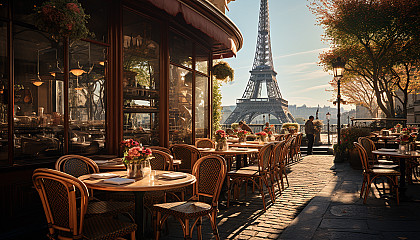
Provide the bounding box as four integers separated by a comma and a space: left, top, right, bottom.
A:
0, 0, 243, 238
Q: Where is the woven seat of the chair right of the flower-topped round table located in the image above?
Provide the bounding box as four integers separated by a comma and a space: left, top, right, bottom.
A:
153, 202, 212, 219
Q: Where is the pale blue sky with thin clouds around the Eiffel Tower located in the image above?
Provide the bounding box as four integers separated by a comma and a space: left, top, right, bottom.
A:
221, 0, 350, 108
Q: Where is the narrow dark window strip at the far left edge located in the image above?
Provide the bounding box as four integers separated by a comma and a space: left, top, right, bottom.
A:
0, 22, 9, 166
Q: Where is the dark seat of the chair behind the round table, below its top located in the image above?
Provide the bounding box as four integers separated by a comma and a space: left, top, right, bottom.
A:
86, 201, 134, 216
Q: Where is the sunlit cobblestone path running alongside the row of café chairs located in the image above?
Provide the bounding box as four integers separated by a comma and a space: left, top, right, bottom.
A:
161, 155, 334, 239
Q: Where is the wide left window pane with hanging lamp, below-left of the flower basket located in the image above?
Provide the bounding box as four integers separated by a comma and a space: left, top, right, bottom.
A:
13, 26, 64, 163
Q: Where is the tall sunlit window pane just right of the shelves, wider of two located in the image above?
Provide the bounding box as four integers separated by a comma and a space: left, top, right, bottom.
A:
169, 65, 193, 144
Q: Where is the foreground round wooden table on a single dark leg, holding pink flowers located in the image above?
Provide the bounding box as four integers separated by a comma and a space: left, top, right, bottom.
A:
79, 170, 196, 239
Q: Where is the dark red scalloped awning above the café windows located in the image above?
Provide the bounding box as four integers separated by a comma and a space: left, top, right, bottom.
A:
147, 0, 237, 57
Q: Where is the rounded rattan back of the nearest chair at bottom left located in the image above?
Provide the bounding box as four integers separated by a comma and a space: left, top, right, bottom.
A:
32, 168, 89, 239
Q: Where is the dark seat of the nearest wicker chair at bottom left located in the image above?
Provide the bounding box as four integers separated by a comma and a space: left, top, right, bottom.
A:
83, 217, 137, 240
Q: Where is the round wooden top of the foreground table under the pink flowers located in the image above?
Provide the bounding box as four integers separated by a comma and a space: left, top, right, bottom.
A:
79, 170, 196, 192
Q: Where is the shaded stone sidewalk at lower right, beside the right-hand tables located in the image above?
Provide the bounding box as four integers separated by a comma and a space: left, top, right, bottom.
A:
279, 163, 420, 240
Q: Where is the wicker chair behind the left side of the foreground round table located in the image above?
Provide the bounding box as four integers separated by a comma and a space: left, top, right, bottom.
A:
55, 155, 134, 218
